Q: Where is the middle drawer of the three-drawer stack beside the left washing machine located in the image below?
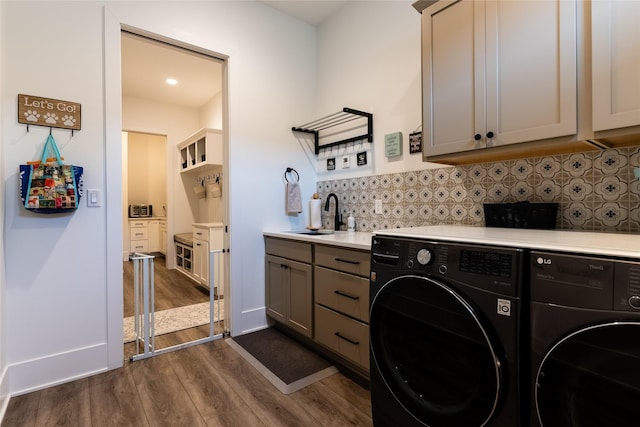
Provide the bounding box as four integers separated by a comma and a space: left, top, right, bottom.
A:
314, 267, 369, 323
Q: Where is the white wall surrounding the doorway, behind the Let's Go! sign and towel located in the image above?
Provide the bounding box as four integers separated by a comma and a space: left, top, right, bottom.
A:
0, 1, 316, 394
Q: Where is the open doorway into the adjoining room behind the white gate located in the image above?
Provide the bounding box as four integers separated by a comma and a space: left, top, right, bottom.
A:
121, 29, 230, 357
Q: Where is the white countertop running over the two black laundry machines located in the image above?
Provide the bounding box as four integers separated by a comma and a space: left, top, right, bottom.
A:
374, 225, 640, 259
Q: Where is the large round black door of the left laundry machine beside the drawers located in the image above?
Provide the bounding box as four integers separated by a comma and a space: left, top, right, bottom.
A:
370, 276, 506, 427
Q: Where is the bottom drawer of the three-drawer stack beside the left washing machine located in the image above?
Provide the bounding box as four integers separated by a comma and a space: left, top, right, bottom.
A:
315, 305, 369, 372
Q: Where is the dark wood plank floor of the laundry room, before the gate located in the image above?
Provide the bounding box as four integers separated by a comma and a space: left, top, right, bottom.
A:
2, 330, 372, 427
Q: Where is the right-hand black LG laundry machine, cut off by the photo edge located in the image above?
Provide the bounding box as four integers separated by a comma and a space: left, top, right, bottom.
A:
531, 251, 640, 427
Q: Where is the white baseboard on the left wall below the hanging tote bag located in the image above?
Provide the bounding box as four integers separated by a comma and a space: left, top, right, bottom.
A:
9, 343, 108, 396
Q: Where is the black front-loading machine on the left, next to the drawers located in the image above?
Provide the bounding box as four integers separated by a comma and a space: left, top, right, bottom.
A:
369, 236, 530, 427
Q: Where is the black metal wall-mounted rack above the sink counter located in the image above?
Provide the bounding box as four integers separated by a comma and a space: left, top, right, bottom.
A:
291, 107, 373, 155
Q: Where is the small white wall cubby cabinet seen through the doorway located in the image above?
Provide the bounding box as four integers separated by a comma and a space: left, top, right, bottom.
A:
178, 129, 223, 173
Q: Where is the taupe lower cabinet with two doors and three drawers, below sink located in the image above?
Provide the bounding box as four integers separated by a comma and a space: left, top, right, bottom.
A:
265, 237, 370, 376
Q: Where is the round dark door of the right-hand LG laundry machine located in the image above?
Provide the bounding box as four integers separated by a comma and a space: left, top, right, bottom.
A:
535, 322, 640, 427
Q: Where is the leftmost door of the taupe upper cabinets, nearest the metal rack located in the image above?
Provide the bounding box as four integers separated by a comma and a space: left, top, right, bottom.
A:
422, 0, 485, 156
